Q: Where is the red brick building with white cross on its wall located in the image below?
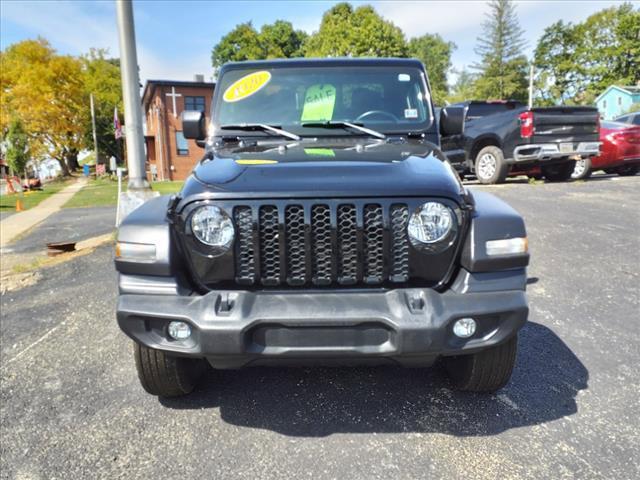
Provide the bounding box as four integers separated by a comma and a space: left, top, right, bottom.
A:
142, 75, 215, 180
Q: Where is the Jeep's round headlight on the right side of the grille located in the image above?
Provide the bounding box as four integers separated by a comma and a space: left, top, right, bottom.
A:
407, 202, 456, 246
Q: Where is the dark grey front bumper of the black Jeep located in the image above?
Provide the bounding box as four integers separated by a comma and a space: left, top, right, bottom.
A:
117, 277, 528, 368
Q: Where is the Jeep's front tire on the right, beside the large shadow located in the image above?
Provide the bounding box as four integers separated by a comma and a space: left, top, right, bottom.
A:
444, 335, 518, 392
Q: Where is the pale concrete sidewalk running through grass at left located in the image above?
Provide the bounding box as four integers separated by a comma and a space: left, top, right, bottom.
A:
0, 178, 87, 248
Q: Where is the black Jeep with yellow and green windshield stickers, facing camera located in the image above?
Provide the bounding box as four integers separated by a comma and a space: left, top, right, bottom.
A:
115, 59, 529, 396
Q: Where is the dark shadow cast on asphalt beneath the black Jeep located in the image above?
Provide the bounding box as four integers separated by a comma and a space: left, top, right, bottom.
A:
160, 322, 589, 437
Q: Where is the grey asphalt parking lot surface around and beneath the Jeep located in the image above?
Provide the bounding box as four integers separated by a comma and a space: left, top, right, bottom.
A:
0, 176, 640, 479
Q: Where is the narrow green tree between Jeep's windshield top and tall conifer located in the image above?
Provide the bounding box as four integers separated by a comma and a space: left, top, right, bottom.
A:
408, 33, 456, 105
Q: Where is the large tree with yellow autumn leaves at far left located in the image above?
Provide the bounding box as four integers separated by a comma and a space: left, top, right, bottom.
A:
0, 38, 122, 175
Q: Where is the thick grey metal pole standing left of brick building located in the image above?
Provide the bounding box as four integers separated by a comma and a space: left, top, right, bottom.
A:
116, 0, 149, 190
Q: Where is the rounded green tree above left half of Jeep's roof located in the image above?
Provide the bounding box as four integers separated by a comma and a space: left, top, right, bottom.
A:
211, 20, 307, 69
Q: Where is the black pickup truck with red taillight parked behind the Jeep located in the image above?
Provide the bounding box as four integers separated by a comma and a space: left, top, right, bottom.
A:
442, 101, 599, 184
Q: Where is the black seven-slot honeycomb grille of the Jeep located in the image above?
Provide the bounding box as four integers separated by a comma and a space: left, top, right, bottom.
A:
233, 201, 409, 286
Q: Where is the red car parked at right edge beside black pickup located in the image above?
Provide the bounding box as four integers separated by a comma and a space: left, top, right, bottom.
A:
571, 122, 640, 179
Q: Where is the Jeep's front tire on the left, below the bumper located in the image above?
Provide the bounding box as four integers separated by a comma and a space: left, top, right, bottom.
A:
133, 342, 206, 397
